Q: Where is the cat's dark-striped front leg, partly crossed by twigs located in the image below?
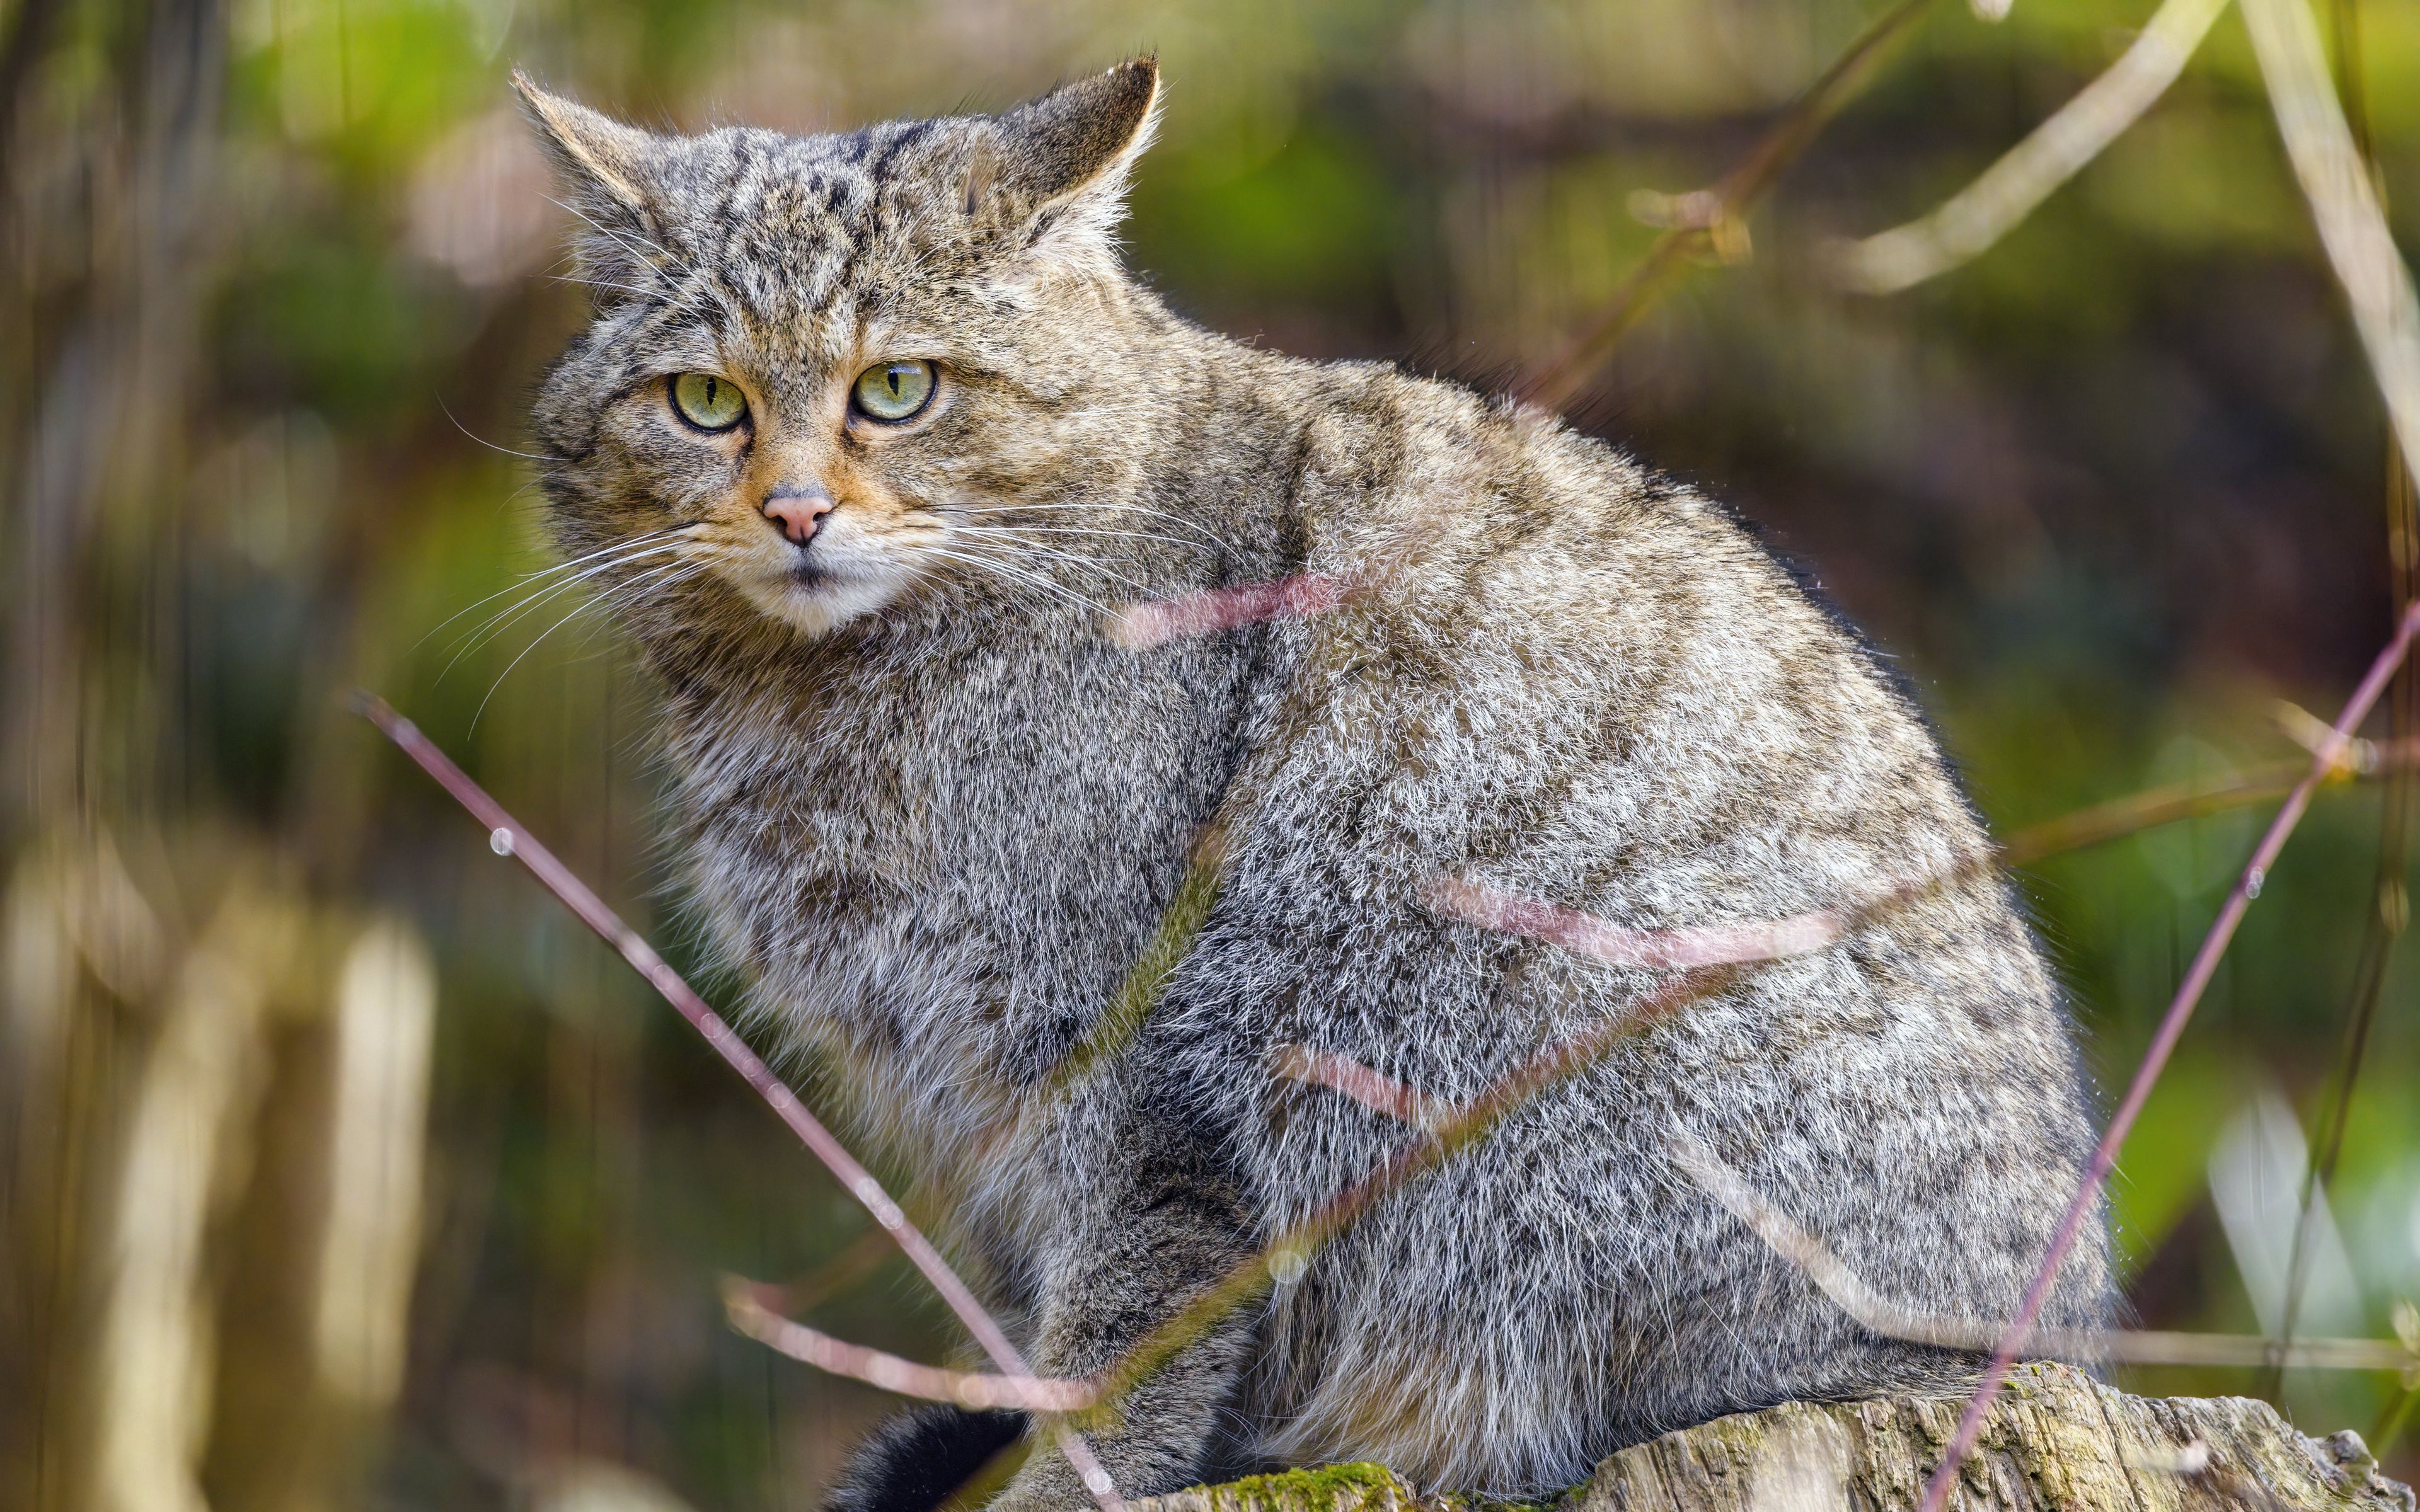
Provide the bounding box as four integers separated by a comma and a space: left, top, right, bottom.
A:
992, 1113, 1261, 1512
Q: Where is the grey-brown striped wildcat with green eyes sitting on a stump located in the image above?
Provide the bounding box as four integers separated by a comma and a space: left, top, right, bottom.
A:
522, 60, 2110, 1512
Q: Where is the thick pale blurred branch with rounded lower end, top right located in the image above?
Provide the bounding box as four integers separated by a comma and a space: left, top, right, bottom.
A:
1824, 0, 2227, 295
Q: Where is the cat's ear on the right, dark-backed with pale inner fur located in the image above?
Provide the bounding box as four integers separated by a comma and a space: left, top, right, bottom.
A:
965, 58, 1159, 270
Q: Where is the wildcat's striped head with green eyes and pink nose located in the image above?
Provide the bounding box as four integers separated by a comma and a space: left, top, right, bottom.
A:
516, 58, 1159, 636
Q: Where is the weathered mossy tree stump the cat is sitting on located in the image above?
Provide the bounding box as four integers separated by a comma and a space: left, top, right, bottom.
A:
1132, 1365, 2412, 1512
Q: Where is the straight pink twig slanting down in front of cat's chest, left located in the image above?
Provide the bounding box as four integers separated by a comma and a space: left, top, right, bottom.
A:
354, 692, 1126, 1512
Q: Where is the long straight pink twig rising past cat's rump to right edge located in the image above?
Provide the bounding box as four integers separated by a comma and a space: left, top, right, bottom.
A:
1924, 592, 2420, 1512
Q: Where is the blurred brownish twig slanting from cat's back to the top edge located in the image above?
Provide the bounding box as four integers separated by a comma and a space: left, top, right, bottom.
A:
1520, 0, 1931, 409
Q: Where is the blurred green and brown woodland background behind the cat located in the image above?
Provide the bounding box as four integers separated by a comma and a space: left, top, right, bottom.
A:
0, 0, 2420, 1512
